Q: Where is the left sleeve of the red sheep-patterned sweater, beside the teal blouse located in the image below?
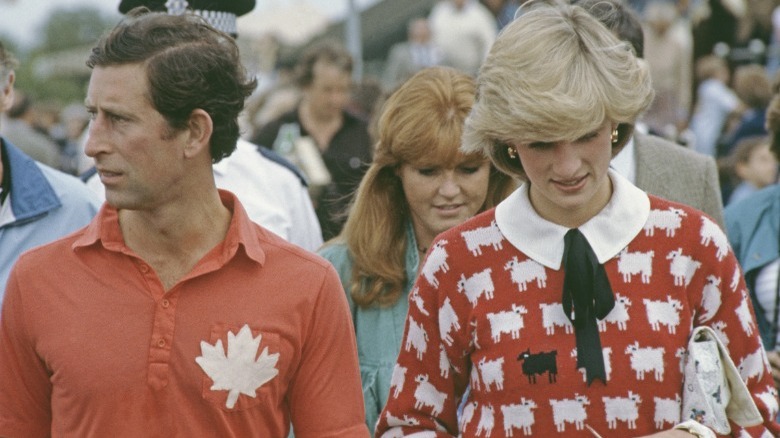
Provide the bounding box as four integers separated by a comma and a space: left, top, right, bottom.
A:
375, 241, 471, 437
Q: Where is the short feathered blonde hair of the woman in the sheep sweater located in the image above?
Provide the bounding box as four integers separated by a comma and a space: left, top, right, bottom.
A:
462, 1, 654, 178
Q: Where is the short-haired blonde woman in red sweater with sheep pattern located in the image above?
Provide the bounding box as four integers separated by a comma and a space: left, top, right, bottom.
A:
376, 2, 780, 438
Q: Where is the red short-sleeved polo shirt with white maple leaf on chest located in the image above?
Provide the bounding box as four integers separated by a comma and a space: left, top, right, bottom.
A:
0, 191, 368, 438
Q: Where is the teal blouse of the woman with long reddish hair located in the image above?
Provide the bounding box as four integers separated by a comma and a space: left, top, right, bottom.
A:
318, 223, 420, 431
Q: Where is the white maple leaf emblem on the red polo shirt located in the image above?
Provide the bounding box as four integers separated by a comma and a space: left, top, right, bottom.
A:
195, 324, 279, 409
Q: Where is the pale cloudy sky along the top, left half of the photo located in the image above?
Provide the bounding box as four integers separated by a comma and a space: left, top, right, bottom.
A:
0, 0, 377, 47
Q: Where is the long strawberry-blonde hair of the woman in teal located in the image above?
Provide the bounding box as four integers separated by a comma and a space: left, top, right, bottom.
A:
336, 67, 515, 307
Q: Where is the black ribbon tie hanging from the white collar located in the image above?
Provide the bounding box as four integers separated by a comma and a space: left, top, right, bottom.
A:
563, 228, 615, 385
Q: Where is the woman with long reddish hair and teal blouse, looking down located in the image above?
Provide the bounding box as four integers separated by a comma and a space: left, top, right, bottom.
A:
319, 67, 515, 430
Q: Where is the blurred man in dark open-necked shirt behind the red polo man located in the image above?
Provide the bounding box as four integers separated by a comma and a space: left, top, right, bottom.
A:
252, 41, 372, 240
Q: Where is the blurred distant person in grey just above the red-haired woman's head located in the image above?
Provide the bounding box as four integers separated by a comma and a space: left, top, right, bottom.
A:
382, 18, 442, 92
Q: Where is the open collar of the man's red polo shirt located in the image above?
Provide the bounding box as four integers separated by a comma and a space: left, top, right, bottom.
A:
73, 190, 265, 264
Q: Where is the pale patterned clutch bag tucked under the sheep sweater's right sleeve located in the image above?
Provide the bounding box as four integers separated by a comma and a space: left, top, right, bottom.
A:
681, 326, 763, 435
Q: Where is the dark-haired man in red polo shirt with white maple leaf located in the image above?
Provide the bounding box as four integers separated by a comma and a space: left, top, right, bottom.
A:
0, 7, 368, 438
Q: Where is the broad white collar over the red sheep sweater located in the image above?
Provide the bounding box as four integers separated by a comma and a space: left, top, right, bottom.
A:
496, 169, 650, 271
